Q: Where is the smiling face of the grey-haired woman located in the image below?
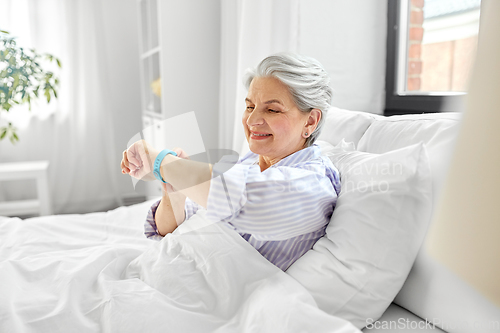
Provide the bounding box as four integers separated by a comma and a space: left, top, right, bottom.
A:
242, 77, 310, 160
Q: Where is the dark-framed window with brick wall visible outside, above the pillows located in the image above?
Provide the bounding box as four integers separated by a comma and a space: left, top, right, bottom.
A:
384, 0, 481, 115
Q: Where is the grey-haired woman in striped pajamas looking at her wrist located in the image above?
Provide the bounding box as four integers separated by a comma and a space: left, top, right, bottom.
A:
121, 53, 340, 270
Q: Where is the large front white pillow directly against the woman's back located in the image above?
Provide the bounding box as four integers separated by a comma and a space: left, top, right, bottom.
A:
287, 142, 432, 328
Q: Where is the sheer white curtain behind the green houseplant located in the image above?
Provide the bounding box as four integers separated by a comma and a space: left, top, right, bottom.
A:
0, 0, 123, 213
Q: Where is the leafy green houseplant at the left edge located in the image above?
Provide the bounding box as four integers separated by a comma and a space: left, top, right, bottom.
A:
0, 30, 61, 143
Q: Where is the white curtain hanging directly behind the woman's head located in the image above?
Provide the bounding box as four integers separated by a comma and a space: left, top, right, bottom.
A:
219, 0, 300, 154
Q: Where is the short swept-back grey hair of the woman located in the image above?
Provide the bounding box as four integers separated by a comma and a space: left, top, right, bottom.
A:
243, 53, 333, 147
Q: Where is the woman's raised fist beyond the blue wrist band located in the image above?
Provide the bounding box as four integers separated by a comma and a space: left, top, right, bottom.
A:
121, 140, 159, 181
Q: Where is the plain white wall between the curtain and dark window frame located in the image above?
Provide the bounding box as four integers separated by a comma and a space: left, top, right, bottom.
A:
299, 0, 387, 114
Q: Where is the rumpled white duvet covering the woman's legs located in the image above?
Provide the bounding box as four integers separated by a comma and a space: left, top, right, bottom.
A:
0, 202, 359, 333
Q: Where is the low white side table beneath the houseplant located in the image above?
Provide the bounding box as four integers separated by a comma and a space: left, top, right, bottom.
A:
0, 161, 52, 216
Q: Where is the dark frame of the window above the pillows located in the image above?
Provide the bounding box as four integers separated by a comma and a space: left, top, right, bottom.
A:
384, 0, 466, 116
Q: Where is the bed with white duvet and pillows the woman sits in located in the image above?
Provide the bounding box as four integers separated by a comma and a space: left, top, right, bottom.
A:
0, 108, 500, 332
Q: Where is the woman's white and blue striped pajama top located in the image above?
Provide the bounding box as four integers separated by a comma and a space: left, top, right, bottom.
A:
144, 145, 340, 271
